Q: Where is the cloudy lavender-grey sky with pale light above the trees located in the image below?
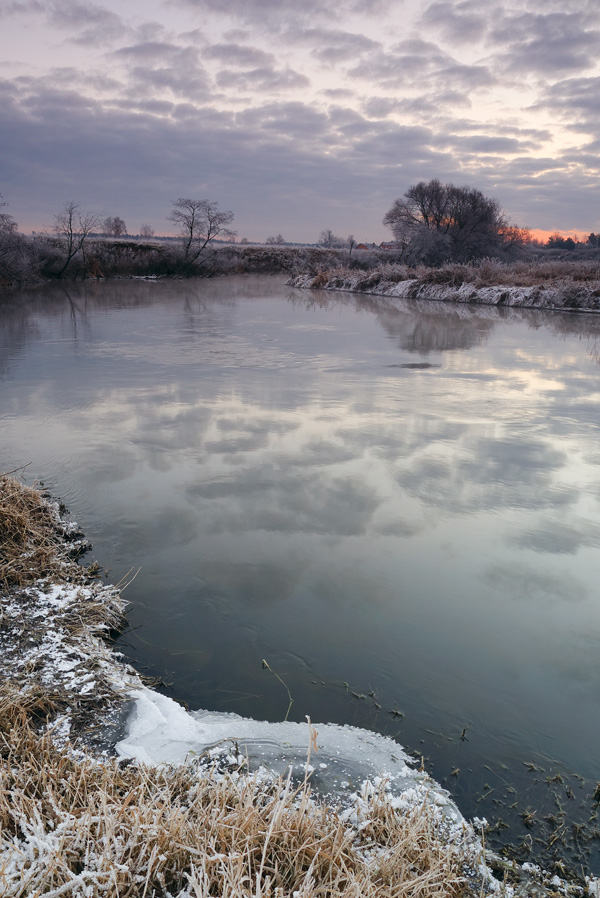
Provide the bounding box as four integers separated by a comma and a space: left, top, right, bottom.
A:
0, 0, 600, 242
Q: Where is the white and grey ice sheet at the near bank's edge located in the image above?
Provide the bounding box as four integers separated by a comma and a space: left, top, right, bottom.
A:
116, 687, 462, 822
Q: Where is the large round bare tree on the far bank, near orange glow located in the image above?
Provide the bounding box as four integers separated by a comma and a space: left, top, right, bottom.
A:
383, 178, 514, 263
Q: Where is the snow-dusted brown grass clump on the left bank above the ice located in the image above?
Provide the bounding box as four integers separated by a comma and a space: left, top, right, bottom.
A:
0, 475, 125, 742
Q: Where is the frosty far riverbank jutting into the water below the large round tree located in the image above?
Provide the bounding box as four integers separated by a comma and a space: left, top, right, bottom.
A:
286, 263, 600, 312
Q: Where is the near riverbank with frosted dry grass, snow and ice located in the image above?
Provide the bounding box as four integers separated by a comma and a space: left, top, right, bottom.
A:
0, 475, 597, 898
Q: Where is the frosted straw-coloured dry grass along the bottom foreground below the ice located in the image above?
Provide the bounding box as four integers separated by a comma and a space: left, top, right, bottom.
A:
0, 691, 478, 898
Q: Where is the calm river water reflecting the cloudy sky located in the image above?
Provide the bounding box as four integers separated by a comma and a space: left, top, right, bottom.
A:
0, 277, 600, 873
